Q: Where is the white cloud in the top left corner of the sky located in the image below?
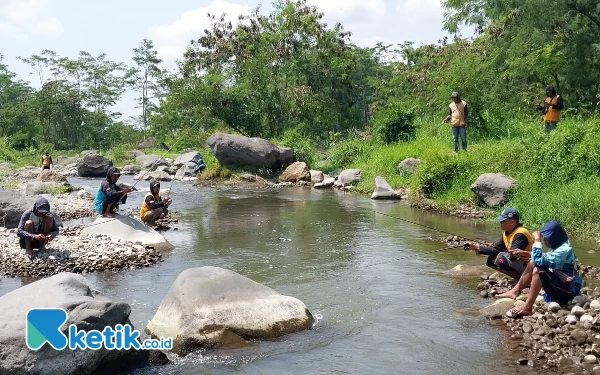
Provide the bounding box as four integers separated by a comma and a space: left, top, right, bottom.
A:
0, 0, 64, 41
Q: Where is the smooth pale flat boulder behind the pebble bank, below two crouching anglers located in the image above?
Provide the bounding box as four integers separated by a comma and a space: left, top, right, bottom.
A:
81, 215, 173, 250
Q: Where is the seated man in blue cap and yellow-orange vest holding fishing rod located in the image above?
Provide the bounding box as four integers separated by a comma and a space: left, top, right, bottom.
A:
465, 208, 533, 280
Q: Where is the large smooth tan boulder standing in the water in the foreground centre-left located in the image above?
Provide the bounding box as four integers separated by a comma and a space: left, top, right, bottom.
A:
146, 267, 314, 355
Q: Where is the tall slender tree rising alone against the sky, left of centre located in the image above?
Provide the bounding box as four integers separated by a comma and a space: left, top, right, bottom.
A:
126, 39, 164, 138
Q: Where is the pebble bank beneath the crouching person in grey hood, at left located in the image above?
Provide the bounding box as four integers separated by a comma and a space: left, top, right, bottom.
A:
0, 226, 162, 277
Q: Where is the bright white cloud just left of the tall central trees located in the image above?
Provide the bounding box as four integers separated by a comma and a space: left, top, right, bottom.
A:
148, 0, 253, 61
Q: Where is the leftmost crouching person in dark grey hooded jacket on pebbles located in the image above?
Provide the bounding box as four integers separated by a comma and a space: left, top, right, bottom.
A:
17, 195, 59, 260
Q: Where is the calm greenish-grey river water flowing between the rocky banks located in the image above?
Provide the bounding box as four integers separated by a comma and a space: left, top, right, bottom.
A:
0, 176, 591, 375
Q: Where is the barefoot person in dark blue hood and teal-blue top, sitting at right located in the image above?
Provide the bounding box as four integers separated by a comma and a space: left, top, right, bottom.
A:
497, 220, 583, 318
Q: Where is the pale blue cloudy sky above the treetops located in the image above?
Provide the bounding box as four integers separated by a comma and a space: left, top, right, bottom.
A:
0, 0, 468, 117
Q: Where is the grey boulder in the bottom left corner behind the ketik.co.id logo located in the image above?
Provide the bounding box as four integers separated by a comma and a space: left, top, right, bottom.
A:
0, 273, 165, 375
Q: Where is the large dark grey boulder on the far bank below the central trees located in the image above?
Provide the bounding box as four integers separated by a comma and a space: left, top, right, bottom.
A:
206, 133, 294, 169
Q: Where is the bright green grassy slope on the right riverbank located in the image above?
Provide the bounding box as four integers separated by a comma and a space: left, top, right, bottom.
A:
330, 119, 600, 235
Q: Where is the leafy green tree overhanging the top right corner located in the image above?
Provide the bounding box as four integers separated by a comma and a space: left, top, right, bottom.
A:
445, 0, 600, 112
